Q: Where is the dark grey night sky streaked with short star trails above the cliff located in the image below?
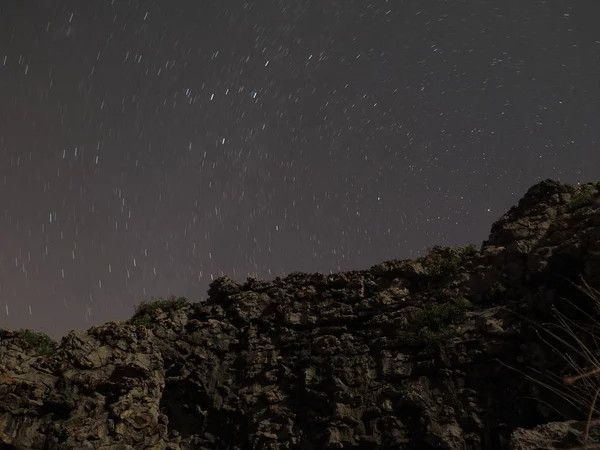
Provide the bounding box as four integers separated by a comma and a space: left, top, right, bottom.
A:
0, 0, 600, 338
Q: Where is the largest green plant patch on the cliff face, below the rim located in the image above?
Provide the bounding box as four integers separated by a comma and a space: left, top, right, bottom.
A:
414, 298, 472, 341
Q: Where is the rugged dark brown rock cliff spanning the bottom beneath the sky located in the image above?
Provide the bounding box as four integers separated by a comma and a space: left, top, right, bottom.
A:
0, 180, 600, 450
